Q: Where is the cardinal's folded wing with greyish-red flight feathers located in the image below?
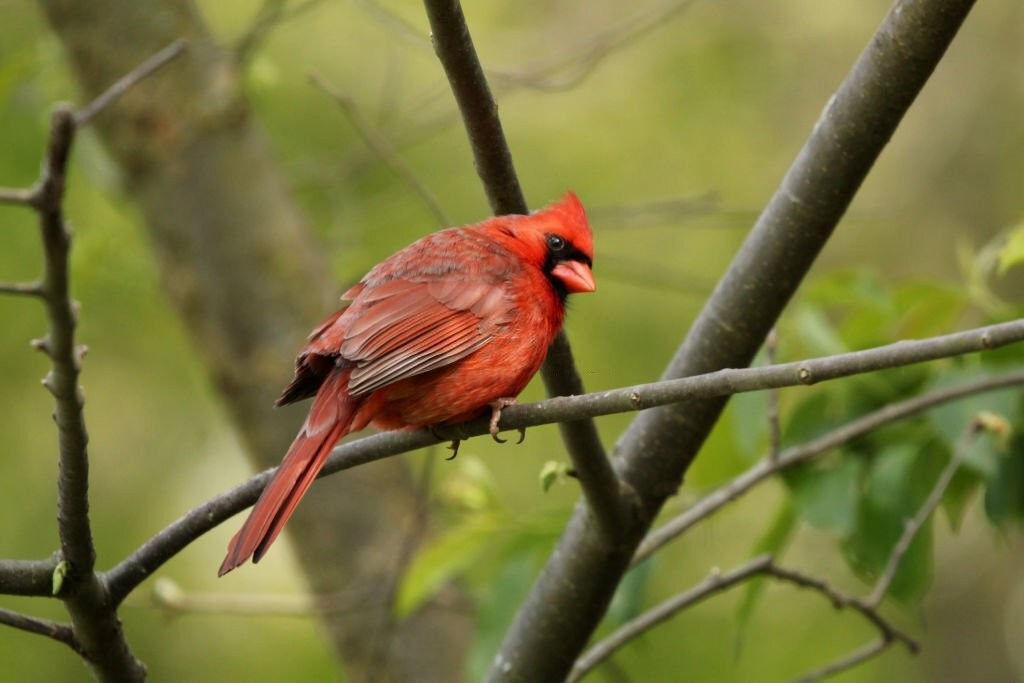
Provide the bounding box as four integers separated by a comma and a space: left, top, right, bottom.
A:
307, 270, 513, 396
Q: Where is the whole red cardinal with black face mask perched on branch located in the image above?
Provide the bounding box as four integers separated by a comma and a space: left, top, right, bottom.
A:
218, 193, 596, 575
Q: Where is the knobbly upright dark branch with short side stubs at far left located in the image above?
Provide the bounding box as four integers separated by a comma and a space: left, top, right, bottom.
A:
0, 36, 183, 681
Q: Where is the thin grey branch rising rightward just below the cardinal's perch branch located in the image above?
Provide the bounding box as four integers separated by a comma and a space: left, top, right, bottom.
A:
633, 371, 1024, 564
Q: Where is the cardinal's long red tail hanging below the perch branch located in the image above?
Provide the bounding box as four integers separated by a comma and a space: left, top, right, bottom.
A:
217, 369, 359, 577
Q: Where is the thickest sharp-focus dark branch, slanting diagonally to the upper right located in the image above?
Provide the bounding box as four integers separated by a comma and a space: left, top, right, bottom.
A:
488, 0, 974, 683
